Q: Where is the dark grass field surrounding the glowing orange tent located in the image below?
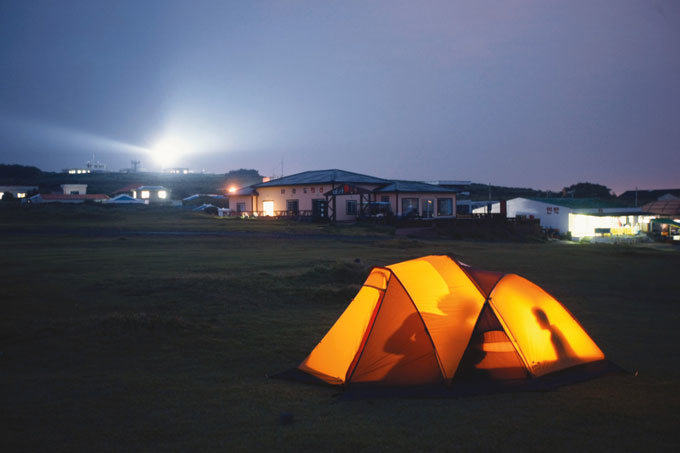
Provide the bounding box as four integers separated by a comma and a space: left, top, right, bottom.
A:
0, 207, 680, 451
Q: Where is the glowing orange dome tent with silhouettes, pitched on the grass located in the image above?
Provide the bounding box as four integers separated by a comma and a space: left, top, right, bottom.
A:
298, 256, 604, 386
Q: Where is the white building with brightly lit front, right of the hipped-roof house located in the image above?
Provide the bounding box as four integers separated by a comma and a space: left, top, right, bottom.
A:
482, 197, 653, 238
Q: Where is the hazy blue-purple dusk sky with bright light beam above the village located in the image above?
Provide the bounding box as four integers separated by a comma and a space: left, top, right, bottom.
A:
0, 0, 680, 193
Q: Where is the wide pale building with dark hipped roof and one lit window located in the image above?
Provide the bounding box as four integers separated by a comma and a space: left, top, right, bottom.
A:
228, 169, 456, 221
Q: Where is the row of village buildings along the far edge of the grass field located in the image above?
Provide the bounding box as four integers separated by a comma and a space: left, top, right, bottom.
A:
0, 161, 680, 242
